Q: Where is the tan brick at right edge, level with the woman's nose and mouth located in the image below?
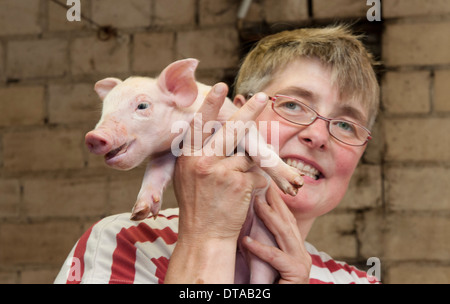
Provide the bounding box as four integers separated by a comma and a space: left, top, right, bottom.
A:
384, 118, 450, 162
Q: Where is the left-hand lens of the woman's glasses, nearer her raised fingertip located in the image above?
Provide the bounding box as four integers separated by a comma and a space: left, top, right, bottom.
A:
274, 96, 316, 125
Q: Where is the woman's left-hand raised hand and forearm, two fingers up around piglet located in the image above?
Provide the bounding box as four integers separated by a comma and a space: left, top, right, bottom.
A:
165, 83, 268, 283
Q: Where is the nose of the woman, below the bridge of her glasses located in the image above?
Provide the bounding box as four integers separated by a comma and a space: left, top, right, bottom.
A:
298, 118, 330, 150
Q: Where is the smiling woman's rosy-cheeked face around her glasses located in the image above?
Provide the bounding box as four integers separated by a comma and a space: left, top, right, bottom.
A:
250, 58, 368, 219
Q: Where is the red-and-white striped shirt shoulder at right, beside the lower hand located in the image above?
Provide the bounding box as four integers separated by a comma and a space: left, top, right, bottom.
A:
305, 242, 380, 284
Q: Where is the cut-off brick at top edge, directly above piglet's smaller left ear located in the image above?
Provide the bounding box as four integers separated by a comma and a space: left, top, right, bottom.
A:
92, 0, 151, 28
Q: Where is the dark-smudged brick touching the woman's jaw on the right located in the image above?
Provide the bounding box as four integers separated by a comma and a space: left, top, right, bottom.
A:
338, 165, 382, 209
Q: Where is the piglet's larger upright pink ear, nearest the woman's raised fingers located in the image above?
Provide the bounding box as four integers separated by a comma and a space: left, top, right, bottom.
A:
158, 59, 198, 107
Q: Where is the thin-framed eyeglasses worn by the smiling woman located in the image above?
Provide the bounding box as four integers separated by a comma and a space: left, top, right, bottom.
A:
269, 95, 372, 146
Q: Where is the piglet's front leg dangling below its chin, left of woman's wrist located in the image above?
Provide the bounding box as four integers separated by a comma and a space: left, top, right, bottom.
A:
131, 152, 176, 220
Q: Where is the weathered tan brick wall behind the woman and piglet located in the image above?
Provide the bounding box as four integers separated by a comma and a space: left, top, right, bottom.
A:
0, 0, 450, 283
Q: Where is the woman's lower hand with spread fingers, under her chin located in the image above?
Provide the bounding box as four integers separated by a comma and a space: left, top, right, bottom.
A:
244, 185, 312, 284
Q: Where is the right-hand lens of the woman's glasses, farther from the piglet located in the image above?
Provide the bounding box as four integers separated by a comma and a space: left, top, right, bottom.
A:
330, 120, 370, 146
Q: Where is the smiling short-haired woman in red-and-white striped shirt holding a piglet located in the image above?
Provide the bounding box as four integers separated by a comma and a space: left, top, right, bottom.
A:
56, 26, 379, 283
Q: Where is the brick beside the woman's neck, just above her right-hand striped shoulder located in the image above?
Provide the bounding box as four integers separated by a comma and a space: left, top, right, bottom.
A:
307, 213, 357, 259
